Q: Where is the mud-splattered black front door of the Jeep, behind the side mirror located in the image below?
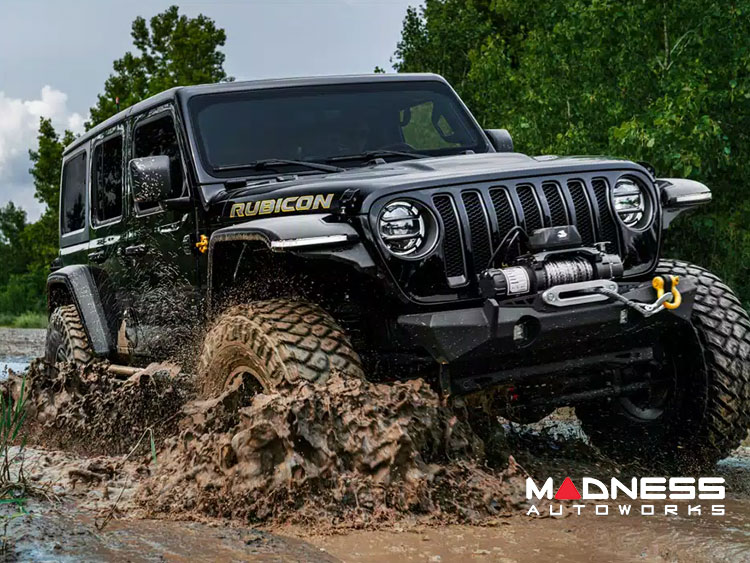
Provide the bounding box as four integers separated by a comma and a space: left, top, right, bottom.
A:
122, 105, 201, 357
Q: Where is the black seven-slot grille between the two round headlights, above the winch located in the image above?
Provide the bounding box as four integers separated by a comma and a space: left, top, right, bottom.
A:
432, 178, 620, 287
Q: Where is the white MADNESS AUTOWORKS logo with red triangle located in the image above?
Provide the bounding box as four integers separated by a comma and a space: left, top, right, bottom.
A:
526, 477, 726, 516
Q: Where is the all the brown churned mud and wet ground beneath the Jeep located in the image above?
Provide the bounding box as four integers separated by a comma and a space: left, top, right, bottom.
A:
0, 354, 750, 561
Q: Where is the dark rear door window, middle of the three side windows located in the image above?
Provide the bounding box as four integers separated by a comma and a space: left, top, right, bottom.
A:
91, 135, 122, 223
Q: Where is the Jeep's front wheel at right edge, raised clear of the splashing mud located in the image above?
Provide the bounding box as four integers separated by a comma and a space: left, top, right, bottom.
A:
576, 260, 750, 470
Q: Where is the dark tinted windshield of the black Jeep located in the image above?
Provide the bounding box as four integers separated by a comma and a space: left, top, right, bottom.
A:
188, 81, 488, 176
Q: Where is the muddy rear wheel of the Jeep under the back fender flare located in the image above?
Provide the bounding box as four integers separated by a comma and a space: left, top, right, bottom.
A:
44, 305, 94, 366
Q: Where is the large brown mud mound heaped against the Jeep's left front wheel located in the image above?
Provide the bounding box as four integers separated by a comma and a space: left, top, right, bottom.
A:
139, 375, 536, 528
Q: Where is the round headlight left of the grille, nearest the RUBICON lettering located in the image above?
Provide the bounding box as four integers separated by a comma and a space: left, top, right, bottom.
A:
378, 200, 437, 259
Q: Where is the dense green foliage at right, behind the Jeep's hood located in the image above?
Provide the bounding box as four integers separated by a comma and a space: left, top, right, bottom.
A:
394, 0, 750, 303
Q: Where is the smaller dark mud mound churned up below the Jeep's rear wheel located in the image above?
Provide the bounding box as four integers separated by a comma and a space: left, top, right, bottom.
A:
5, 360, 194, 455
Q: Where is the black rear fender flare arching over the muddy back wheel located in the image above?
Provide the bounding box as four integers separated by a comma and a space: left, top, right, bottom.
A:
47, 265, 114, 357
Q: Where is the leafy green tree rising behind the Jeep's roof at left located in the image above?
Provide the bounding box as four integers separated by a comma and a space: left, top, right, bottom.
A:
86, 6, 233, 128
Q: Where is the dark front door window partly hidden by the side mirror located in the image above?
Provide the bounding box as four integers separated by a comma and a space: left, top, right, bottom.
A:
133, 114, 184, 211
